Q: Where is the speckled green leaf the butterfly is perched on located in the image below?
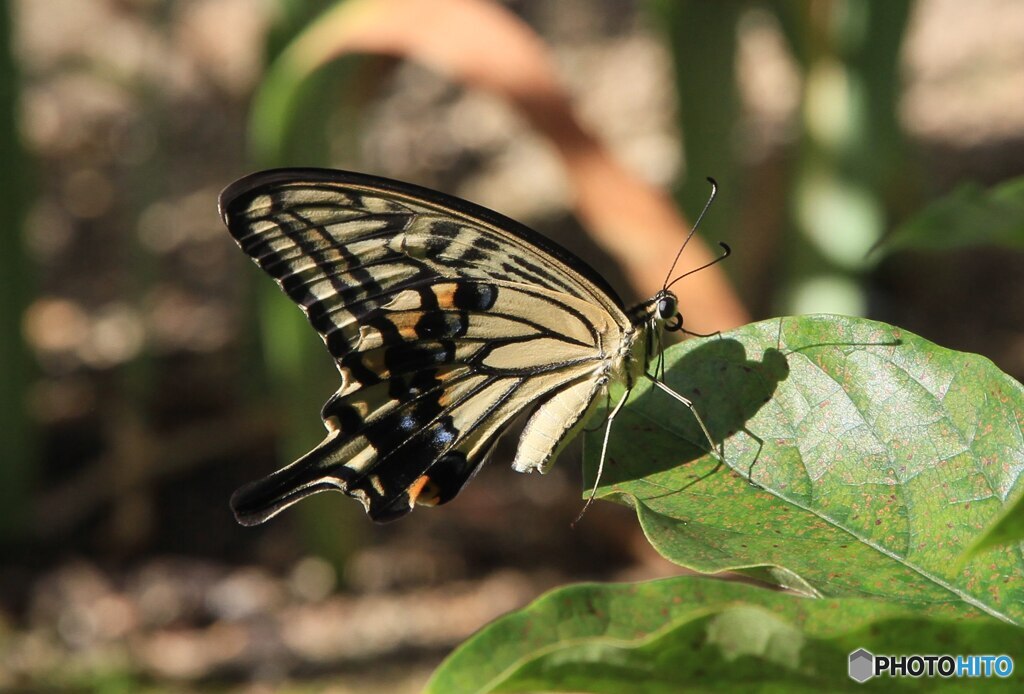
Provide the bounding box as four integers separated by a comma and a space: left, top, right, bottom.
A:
585, 316, 1024, 623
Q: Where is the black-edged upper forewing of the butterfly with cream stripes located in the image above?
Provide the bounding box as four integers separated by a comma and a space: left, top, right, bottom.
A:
220, 169, 628, 332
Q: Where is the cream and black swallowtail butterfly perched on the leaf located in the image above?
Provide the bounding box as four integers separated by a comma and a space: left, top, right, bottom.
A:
220, 169, 729, 525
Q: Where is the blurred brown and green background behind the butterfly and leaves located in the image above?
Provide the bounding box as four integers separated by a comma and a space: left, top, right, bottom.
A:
0, 0, 1024, 692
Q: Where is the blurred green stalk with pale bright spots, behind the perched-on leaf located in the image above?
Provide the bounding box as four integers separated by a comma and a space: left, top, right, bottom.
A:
769, 0, 912, 315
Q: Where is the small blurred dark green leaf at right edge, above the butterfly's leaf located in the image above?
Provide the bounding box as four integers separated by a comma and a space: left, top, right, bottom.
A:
884, 176, 1024, 251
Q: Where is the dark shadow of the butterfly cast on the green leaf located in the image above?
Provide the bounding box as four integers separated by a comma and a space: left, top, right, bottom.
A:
584, 338, 790, 496
